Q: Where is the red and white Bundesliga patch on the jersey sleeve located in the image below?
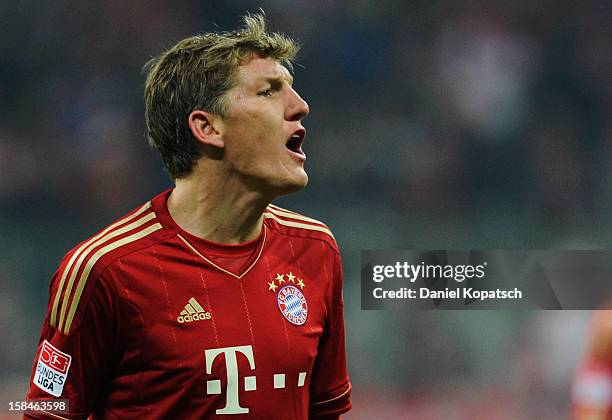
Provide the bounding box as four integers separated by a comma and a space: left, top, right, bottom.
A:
34, 340, 72, 397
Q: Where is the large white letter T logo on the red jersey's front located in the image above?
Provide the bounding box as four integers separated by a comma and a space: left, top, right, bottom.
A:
204, 346, 257, 414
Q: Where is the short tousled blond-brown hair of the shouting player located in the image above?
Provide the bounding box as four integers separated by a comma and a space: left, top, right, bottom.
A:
144, 13, 299, 179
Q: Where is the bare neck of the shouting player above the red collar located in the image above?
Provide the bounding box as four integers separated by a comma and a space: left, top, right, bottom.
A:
168, 169, 272, 244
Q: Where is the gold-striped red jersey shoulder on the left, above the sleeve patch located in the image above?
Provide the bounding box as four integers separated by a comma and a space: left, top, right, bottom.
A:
49, 202, 164, 334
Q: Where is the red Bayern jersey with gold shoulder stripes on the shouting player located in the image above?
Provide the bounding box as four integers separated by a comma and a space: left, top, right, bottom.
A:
27, 191, 351, 419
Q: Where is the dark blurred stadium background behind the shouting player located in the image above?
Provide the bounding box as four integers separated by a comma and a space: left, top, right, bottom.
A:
0, 0, 612, 419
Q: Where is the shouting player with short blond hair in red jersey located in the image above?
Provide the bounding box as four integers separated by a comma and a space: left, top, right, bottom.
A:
26, 11, 351, 419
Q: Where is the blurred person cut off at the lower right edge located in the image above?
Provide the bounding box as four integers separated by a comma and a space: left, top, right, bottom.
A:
572, 310, 612, 420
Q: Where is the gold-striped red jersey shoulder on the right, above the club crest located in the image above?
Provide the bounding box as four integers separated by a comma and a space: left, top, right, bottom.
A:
264, 204, 339, 253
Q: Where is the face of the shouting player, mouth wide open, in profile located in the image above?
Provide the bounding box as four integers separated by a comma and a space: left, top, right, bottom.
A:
221, 55, 309, 195
